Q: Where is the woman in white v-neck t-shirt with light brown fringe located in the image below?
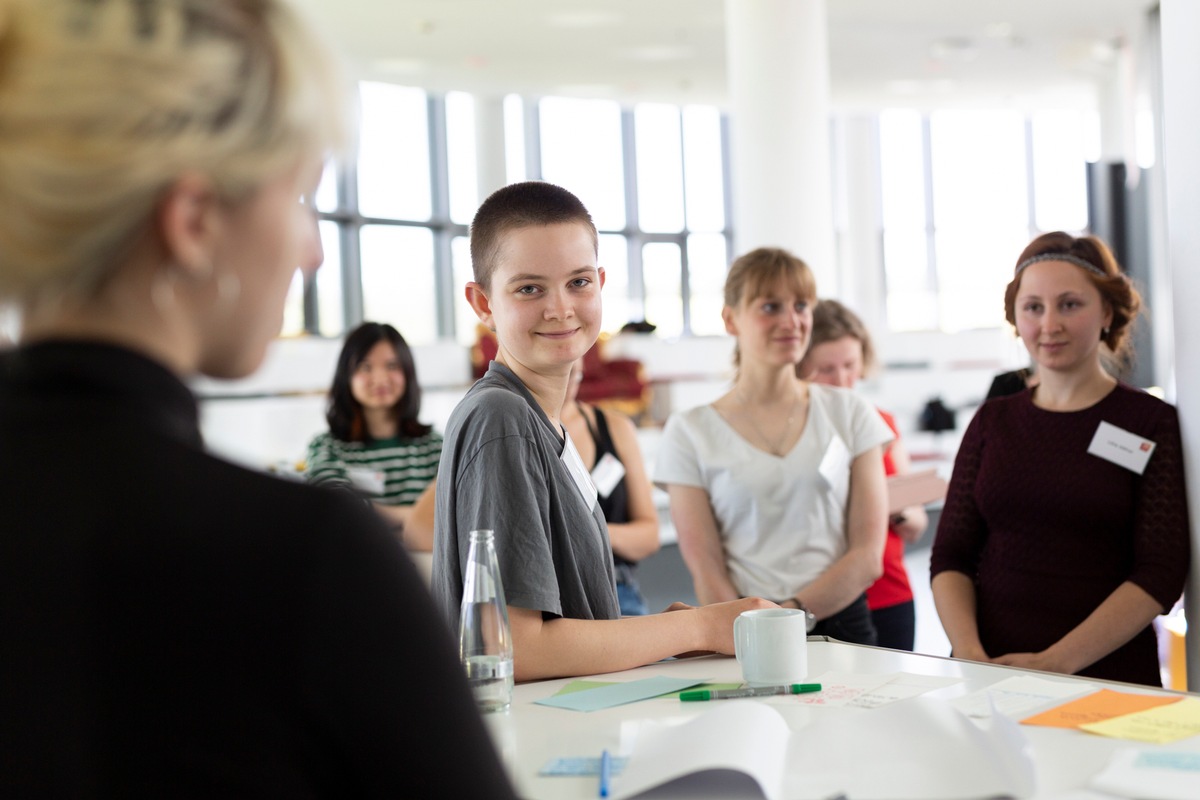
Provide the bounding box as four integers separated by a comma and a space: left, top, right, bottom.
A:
654, 248, 892, 644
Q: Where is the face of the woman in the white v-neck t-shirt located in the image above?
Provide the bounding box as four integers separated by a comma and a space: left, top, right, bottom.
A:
721, 283, 812, 366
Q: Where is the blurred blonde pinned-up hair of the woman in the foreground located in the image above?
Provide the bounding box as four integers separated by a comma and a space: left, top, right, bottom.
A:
0, 0, 346, 299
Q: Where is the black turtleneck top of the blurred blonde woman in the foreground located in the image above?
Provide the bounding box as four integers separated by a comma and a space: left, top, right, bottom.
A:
0, 342, 512, 798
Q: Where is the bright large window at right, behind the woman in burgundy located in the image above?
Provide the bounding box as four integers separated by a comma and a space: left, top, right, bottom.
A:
880, 110, 1087, 332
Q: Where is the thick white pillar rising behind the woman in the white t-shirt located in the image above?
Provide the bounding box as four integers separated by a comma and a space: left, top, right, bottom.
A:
725, 0, 838, 295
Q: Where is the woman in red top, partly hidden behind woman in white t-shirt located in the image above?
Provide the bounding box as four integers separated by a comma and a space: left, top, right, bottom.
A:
797, 300, 929, 650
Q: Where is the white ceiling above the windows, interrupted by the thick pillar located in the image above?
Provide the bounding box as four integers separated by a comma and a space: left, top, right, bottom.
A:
288, 0, 1157, 108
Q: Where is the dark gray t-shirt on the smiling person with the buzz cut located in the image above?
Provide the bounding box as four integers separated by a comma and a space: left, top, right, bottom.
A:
432, 361, 620, 630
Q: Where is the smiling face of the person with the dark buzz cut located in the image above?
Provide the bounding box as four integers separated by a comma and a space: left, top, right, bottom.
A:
467, 223, 604, 383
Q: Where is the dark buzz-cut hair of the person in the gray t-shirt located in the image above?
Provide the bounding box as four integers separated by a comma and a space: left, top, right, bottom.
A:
470, 181, 600, 289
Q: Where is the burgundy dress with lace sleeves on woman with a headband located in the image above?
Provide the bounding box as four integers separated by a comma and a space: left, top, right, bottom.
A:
930, 384, 1189, 686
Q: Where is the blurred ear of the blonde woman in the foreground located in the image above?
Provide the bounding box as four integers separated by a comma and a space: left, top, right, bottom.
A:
157, 173, 221, 281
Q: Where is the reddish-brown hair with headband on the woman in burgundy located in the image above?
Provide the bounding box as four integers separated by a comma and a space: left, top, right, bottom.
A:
1004, 230, 1141, 362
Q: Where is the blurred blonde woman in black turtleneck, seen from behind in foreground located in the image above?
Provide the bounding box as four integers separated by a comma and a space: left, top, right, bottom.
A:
0, 0, 512, 798
